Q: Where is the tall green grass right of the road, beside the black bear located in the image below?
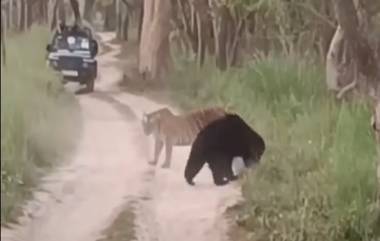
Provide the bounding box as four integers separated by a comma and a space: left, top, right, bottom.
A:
171, 53, 380, 241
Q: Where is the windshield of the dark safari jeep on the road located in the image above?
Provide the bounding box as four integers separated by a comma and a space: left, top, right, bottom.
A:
54, 35, 90, 51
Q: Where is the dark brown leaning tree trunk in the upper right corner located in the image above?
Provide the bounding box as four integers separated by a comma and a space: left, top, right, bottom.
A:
334, 0, 380, 97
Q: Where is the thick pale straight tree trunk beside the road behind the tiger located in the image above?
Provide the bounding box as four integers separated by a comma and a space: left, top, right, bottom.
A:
139, 0, 171, 79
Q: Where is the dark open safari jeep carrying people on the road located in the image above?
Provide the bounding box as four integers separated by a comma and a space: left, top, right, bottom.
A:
46, 24, 98, 92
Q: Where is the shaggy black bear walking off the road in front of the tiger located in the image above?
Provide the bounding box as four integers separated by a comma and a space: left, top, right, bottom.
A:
185, 114, 265, 186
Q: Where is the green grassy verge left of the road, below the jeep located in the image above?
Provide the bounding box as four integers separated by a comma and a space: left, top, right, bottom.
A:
1, 27, 80, 223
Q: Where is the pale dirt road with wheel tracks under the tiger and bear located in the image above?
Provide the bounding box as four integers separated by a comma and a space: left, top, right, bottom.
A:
1, 33, 239, 241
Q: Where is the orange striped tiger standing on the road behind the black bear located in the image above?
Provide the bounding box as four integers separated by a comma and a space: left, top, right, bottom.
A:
142, 107, 226, 168
